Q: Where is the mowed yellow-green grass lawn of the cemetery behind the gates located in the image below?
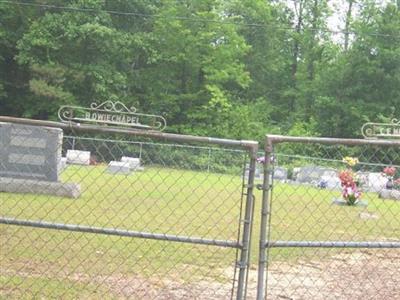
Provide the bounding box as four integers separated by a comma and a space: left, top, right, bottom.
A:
0, 166, 400, 298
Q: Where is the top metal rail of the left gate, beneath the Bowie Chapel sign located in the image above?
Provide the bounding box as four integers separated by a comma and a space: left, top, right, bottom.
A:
0, 116, 258, 155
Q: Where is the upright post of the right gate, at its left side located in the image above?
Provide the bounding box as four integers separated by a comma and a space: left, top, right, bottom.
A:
257, 138, 273, 300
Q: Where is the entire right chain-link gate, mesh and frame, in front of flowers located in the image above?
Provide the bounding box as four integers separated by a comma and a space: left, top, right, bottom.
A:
257, 135, 400, 299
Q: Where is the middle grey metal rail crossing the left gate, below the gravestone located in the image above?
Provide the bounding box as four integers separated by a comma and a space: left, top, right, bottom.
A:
0, 217, 242, 249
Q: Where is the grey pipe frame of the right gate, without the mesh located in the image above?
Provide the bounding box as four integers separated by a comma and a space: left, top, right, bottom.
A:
256, 134, 400, 300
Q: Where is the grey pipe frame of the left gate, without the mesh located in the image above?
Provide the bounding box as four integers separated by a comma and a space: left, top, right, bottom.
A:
0, 116, 258, 300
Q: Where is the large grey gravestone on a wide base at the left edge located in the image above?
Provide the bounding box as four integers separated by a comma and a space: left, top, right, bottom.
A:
0, 122, 81, 198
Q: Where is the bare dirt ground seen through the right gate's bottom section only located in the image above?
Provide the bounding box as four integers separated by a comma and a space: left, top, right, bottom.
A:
249, 250, 400, 300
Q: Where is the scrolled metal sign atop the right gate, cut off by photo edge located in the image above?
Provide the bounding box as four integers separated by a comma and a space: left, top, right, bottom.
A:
361, 119, 400, 139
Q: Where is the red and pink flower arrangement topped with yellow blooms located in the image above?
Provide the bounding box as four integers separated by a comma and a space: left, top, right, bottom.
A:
339, 156, 361, 205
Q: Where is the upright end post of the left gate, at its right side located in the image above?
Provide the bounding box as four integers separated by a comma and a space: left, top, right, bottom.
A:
236, 143, 258, 300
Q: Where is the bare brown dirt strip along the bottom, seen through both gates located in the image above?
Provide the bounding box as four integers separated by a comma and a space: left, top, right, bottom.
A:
0, 250, 400, 300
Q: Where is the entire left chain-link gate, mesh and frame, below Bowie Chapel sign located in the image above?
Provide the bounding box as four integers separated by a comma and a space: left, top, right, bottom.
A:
0, 117, 258, 299
